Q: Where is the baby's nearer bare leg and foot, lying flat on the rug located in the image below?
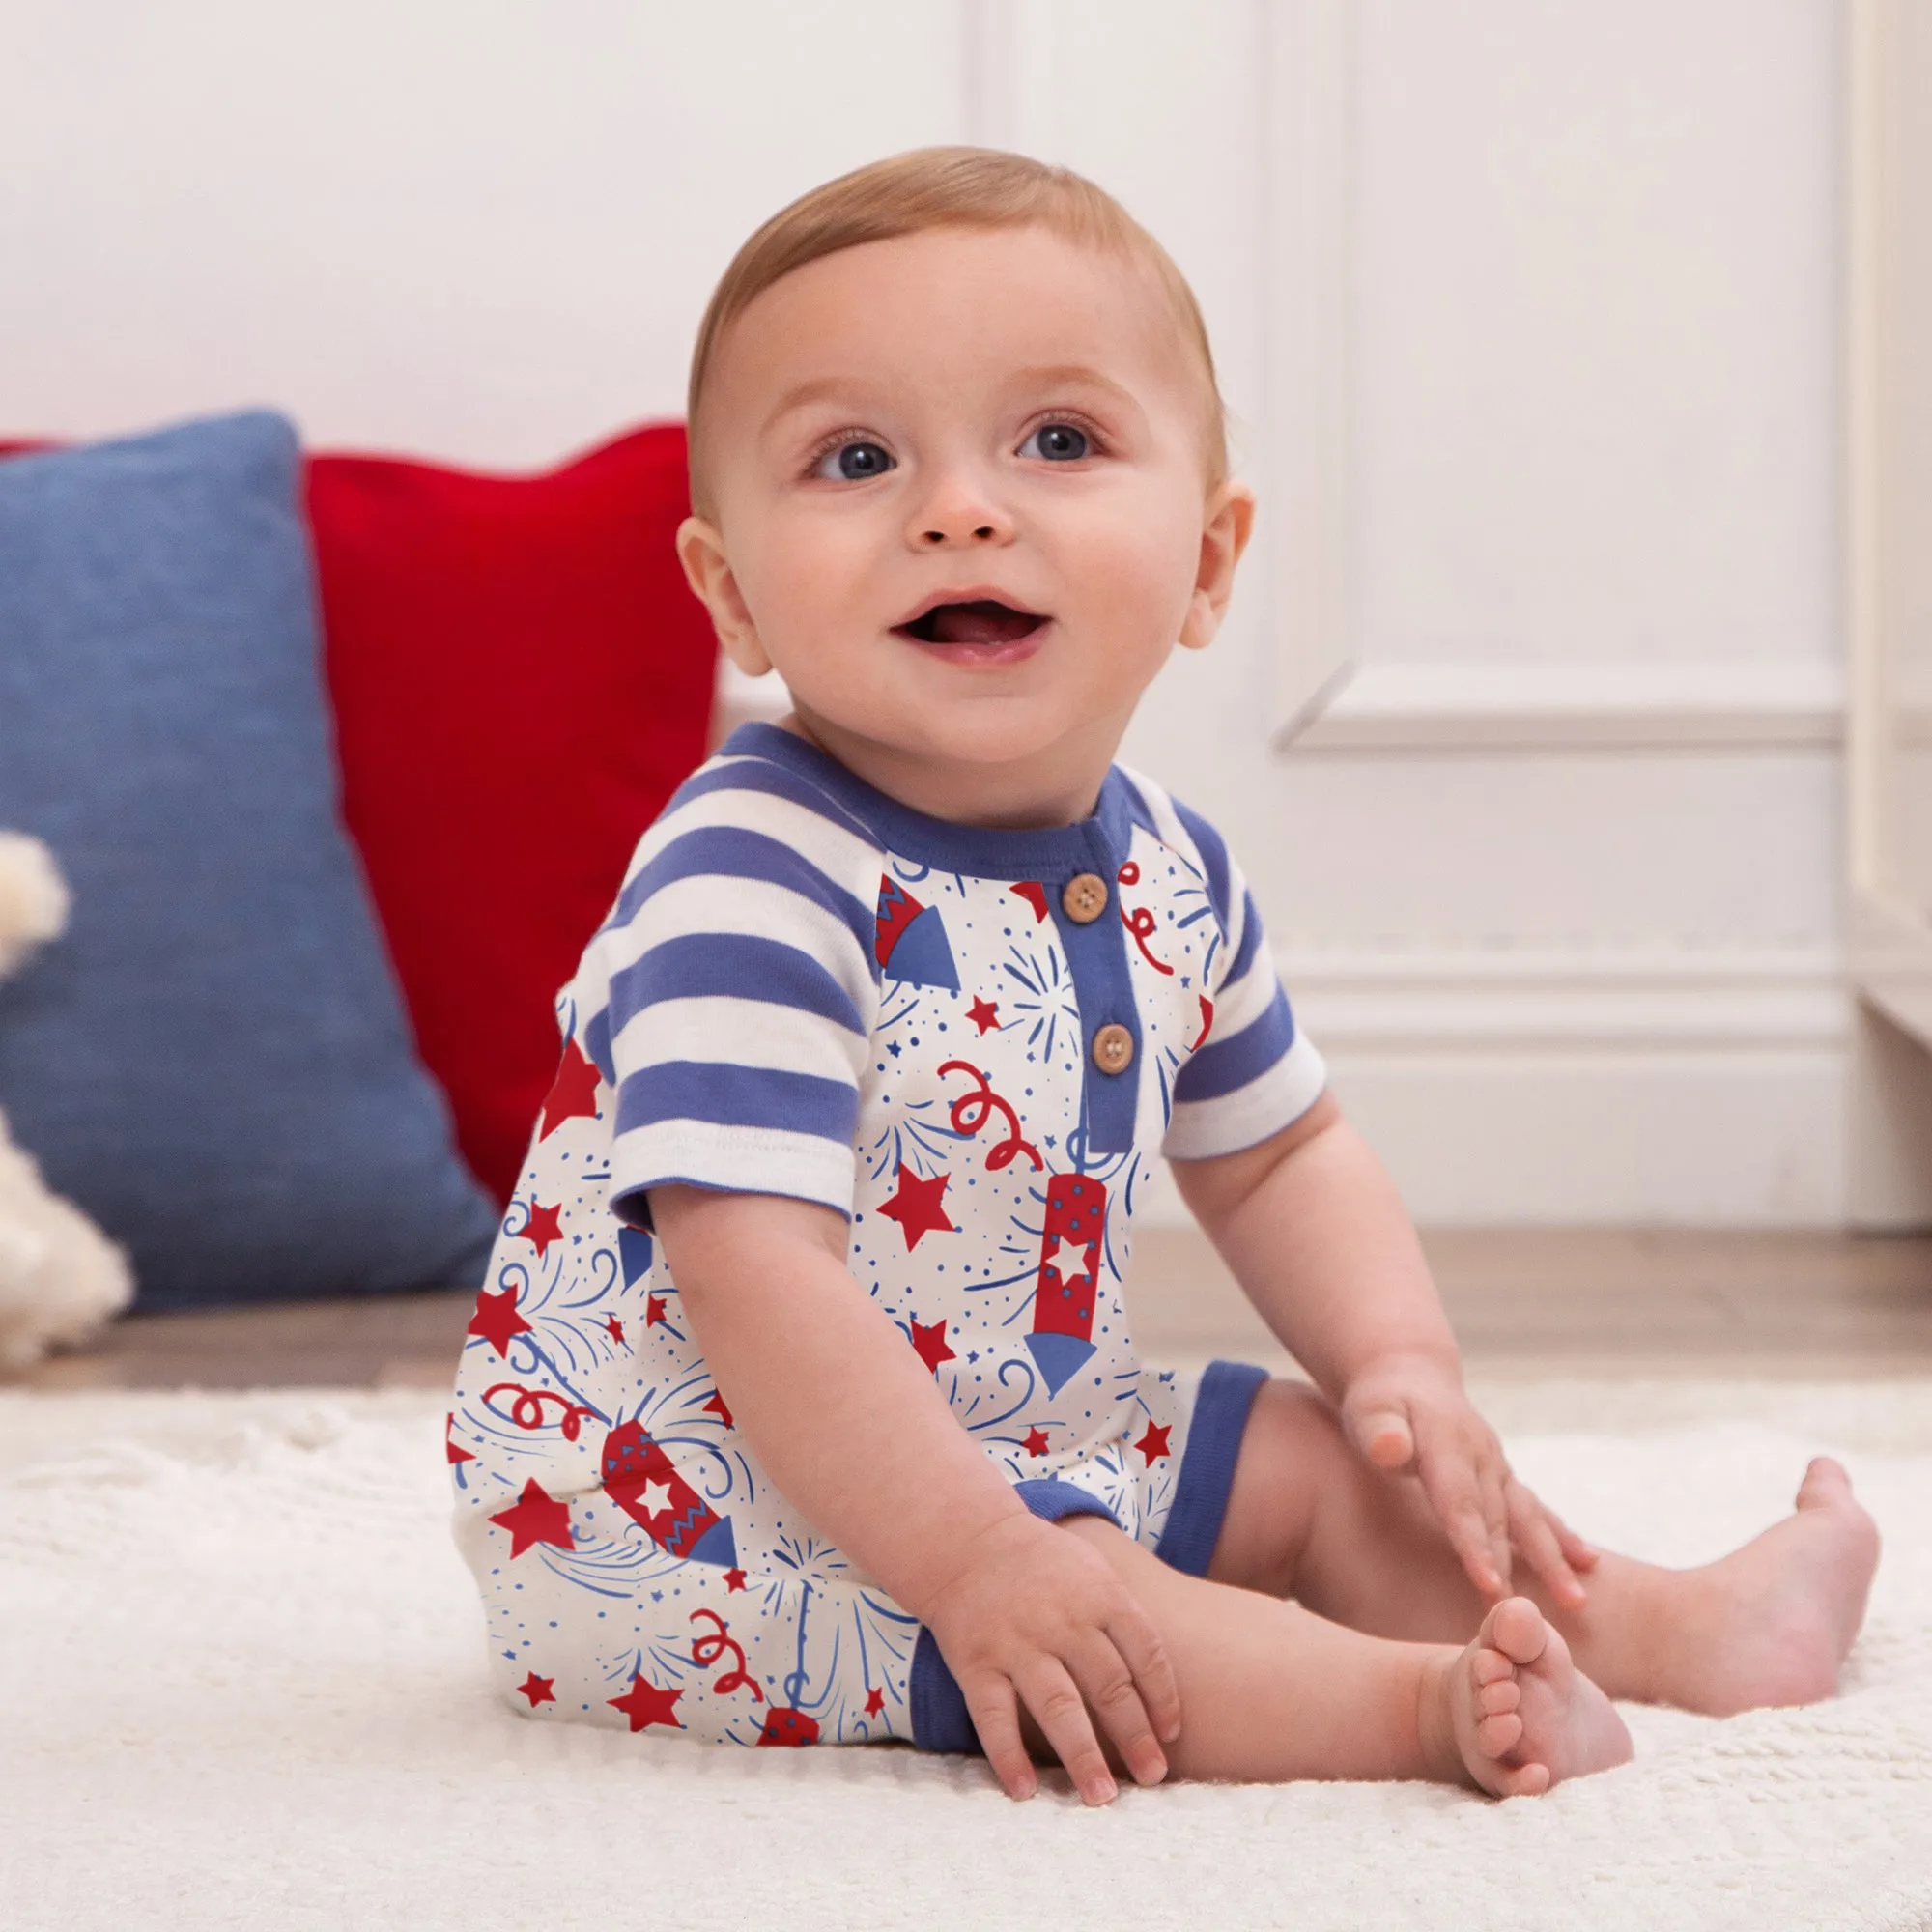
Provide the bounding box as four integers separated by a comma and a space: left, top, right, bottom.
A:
1028, 1517, 1631, 1797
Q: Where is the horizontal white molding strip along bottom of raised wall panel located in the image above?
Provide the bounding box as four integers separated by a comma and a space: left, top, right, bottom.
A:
1293, 659, 1845, 755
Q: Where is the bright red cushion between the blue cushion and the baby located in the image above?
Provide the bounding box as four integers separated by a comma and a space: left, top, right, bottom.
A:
309, 425, 715, 1200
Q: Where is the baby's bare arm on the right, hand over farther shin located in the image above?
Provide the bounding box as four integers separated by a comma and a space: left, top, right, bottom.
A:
1175, 1094, 1596, 1607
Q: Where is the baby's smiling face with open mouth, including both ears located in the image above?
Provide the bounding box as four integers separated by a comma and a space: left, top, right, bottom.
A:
680, 228, 1250, 823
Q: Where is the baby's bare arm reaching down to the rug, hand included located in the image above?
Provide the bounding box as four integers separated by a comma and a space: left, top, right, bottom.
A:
651, 1186, 1180, 1804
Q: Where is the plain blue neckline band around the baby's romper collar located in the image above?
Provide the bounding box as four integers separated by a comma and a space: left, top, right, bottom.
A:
721, 724, 1134, 883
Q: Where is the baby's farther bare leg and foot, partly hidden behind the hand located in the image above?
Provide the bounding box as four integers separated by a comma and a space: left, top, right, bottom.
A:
1209, 1381, 1878, 1716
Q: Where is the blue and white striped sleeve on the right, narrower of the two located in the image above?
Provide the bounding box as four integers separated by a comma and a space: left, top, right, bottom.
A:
1161, 802, 1327, 1161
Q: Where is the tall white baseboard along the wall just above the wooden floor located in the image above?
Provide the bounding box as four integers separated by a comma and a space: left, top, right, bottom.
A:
1148, 949, 1851, 1229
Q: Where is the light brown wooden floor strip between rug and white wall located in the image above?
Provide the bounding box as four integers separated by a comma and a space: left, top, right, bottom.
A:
23, 1229, 1932, 1389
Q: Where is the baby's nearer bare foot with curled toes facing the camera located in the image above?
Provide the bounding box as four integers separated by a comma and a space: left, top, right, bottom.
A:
1439, 1596, 1631, 1799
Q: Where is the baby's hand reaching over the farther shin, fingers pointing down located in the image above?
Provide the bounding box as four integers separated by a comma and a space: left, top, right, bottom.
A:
1341, 1356, 1596, 1609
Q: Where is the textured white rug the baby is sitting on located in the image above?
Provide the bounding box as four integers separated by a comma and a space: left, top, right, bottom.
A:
0, 1383, 1932, 1932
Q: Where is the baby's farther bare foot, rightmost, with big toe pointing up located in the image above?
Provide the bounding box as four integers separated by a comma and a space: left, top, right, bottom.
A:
1662, 1457, 1878, 1718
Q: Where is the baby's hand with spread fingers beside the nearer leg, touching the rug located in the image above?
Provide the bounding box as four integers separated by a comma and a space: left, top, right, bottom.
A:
923, 1517, 1180, 1804
